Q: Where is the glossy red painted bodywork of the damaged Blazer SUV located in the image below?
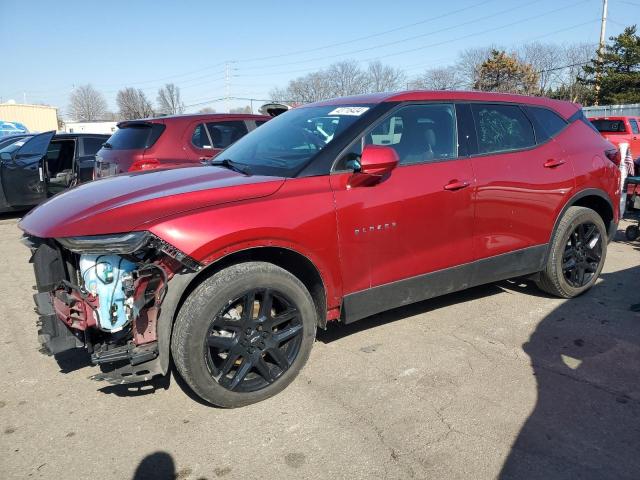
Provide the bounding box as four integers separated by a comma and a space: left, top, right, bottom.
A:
20, 92, 619, 319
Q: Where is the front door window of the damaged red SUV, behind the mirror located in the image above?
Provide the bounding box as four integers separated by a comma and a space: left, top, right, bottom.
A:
364, 104, 458, 165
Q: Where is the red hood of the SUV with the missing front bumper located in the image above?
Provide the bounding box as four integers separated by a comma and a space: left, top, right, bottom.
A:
19, 166, 284, 238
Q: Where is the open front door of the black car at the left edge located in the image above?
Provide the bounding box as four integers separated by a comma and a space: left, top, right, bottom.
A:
0, 131, 55, 207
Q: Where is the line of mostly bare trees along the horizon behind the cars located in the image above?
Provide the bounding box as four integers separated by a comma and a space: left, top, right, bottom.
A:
69, 25, 640, 121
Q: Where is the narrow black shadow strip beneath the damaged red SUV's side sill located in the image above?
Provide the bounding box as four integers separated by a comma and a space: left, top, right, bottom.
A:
316, 284, 503, 343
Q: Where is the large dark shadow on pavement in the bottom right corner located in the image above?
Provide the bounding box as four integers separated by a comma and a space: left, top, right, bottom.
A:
499, 266, 640, 480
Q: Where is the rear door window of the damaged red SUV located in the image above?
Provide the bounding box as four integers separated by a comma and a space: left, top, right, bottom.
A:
471, 104, 536, 153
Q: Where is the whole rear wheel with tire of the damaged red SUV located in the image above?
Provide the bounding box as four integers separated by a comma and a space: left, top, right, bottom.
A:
536, 207, 607, 298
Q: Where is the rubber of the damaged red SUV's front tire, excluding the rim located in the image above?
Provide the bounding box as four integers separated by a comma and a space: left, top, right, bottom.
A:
177, 262, 317, 407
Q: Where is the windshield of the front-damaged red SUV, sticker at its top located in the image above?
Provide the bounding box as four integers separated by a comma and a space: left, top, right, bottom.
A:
215, 105, 371, 177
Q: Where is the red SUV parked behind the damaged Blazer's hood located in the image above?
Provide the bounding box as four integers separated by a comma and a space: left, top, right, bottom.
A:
94, 114, 271, 178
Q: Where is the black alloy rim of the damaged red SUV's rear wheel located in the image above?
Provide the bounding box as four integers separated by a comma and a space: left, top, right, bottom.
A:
562, 222, 602, 288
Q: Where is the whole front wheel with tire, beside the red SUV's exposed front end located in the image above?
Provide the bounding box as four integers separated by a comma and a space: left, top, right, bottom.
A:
171, 262, 317, 408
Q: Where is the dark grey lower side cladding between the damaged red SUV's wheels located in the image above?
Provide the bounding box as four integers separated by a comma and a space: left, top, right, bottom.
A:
342, 244, 548, 323
